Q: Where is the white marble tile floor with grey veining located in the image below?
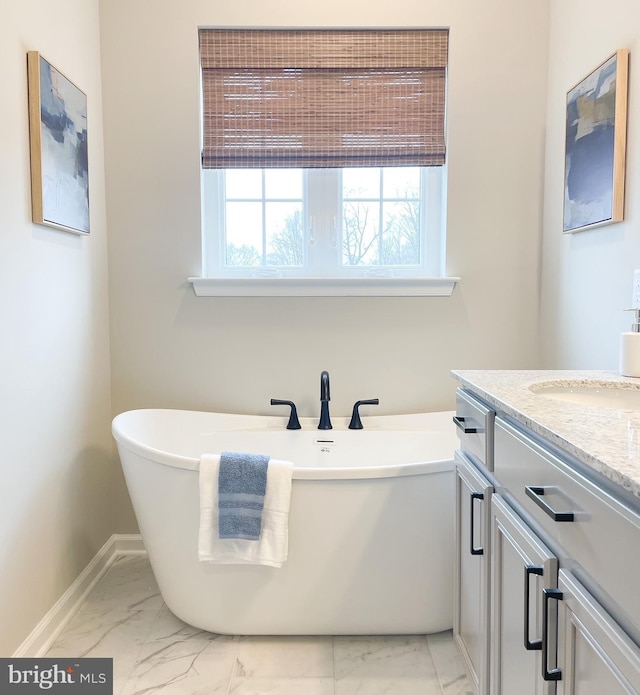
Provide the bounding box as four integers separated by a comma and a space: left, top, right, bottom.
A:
46, 556, 471, 695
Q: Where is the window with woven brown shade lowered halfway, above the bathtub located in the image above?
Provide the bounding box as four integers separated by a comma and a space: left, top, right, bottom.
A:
195, 29, 456, 296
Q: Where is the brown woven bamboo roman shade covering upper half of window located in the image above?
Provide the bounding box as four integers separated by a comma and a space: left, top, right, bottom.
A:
200, 29, 449, 169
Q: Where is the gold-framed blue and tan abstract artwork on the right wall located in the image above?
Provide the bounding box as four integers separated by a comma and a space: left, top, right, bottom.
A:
563, 49, 629, 233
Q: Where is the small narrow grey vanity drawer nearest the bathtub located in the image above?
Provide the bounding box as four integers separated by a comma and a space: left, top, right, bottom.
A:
454, 388, 496, 471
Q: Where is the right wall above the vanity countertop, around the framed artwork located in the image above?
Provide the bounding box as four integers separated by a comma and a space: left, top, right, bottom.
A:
541, 0, 640, 370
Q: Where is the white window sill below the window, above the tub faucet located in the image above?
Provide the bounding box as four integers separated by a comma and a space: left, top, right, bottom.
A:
189, 277, 460, 297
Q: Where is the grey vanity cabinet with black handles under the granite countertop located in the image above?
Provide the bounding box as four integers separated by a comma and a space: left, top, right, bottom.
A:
454, 389, 640, 695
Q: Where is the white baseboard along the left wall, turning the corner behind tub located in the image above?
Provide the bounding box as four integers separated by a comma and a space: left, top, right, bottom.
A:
13, 534, 147, 658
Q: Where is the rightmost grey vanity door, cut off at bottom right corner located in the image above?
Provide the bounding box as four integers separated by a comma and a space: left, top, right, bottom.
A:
550, 570, 640, 695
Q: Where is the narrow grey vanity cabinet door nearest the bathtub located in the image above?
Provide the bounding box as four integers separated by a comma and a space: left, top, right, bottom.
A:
453, 452, 493, 695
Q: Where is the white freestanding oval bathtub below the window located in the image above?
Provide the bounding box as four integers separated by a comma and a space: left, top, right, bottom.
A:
113, 410, 457, 635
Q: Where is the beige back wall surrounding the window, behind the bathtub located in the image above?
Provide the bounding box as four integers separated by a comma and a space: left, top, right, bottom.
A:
100, 0, 548, 426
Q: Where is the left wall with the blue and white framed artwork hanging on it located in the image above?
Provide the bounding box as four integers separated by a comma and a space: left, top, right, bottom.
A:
0, 0, 117, 656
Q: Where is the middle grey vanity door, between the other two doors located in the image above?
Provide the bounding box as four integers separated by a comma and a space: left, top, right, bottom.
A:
490, 494, 556, 695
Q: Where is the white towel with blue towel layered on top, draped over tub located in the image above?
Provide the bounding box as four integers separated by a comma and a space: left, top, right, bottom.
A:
198, 452, 293, 567
